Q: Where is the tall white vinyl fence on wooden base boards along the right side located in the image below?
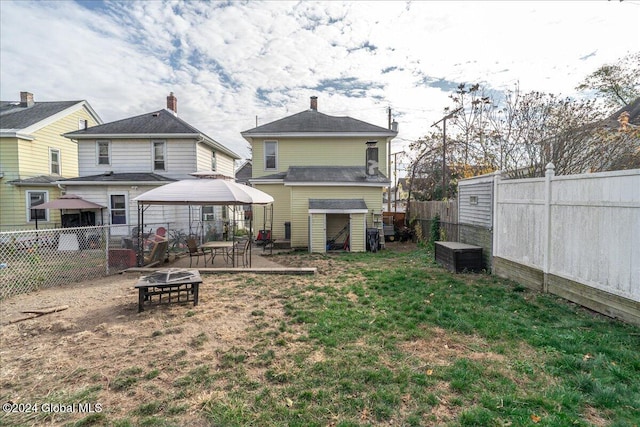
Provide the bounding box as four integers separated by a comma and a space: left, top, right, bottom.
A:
493, 165, 640, 322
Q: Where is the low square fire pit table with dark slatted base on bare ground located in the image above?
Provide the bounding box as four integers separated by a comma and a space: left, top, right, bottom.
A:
135, 268, 202, 312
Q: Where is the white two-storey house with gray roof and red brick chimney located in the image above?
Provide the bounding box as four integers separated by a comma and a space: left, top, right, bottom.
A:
58, 93, 240, 239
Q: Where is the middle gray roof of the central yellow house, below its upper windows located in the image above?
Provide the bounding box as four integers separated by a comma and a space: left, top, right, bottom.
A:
284, 166, 389, 184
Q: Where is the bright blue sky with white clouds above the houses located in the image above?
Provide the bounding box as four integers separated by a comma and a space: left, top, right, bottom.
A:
0, 0, 640, 167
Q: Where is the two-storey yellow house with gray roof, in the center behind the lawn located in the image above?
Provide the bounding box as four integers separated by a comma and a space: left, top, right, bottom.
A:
241, 96, 397, 253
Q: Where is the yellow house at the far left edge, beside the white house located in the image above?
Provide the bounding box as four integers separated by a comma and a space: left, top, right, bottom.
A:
0, 92, 102, 230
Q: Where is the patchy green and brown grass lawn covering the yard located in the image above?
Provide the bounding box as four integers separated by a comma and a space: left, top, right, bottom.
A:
0, 248, 640, 427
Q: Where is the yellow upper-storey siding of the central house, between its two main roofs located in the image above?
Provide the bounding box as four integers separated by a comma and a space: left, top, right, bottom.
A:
252, 137, 387, 178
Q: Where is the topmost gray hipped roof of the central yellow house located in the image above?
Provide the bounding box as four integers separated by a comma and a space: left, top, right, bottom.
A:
241, 110, 397, 137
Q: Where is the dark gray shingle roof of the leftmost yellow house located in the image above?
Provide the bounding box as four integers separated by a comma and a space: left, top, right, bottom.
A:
0, 101, 82, 129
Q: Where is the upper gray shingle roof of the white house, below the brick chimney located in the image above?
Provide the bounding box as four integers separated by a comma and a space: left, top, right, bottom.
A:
65, 109, 202, 138
